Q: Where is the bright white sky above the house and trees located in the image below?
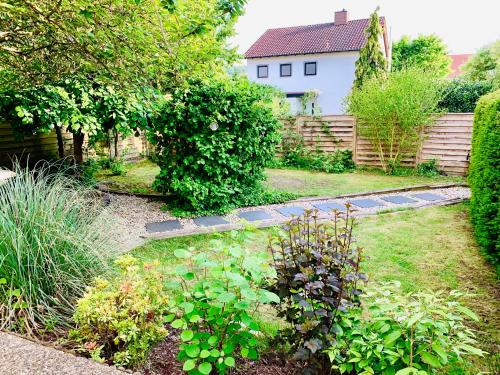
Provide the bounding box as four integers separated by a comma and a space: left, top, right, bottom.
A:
231, 0, 500, 54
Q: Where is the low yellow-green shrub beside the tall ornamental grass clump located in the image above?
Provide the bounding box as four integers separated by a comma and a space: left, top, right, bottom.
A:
70, 255, 169, 367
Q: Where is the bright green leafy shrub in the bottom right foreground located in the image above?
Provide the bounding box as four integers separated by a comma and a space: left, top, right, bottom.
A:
328, 282, 484, 375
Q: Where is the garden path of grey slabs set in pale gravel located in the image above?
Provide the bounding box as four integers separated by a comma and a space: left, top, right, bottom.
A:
107, 185, 470, 249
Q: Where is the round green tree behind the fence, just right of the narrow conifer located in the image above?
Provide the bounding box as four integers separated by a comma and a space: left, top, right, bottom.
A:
392, 34, 451, 77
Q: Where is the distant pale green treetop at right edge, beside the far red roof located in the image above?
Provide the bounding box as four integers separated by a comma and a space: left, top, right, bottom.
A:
462, 40, 500, 88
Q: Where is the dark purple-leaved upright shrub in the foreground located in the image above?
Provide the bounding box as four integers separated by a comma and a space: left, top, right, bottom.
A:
269, 207, 367, 373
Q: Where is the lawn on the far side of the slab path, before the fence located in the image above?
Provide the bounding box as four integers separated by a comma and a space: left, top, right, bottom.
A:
97, 161, 464, 196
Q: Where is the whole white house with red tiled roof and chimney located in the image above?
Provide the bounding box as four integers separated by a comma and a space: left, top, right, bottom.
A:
245, 9, 391, 115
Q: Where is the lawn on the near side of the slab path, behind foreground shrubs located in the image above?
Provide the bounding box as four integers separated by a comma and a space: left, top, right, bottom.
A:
134, 204, 500, 373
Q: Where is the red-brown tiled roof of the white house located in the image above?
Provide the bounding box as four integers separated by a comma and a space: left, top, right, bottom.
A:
245, 17, 385, 59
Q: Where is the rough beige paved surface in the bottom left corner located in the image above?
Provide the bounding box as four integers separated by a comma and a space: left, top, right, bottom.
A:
0, 332, 127, 375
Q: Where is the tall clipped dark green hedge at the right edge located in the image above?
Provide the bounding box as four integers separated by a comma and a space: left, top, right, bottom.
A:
468, 90, 500, 264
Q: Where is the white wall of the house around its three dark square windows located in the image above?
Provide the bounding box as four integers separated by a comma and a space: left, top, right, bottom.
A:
247, 52, 359, 115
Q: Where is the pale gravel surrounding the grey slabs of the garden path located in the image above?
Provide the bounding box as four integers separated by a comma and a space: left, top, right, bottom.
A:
110, 186, 470, 252
